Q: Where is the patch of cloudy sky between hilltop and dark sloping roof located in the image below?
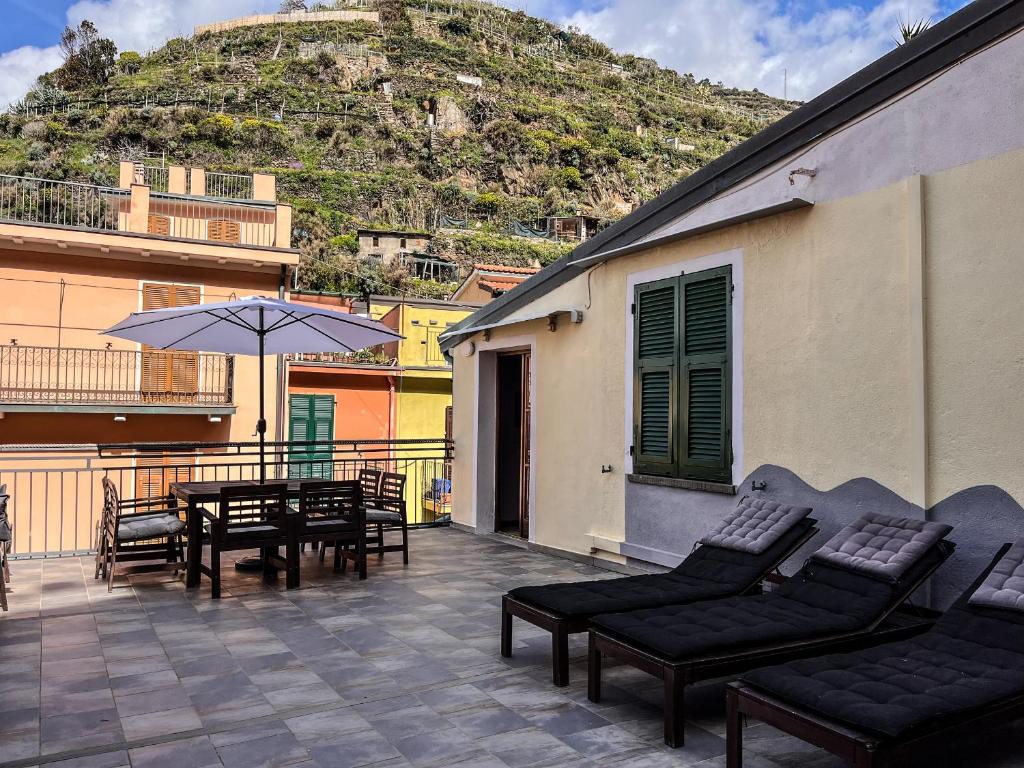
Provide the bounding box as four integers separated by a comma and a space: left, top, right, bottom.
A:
502, 0, 967, 99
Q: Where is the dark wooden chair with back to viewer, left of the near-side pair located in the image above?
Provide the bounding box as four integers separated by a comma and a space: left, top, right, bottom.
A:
201, 482, 299, 599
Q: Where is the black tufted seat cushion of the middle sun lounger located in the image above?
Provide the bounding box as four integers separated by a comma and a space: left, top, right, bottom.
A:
592, 546, 943, 660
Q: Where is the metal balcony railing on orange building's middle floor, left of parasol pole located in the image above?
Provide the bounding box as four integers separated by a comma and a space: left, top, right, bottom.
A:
0, 345, 234, 406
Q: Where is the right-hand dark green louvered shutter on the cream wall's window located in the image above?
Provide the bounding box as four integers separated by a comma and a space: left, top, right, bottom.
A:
679, 267, 732, 482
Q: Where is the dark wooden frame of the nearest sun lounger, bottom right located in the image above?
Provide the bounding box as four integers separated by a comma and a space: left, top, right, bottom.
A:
725, 544, 1024, 768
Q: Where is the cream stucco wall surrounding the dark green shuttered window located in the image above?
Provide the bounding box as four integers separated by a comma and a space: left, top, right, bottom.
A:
454, 151, 1024, 553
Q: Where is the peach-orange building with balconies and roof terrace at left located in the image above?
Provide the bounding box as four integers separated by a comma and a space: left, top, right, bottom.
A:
0, 163, 299, 495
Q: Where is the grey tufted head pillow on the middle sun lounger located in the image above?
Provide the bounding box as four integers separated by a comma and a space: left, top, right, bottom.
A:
812, 513, 952, 582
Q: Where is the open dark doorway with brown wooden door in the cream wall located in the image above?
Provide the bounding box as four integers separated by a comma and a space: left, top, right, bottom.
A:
495, 352, 530, 539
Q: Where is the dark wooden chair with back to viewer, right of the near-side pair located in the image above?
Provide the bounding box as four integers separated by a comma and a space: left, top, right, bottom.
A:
294, 478, 367, 580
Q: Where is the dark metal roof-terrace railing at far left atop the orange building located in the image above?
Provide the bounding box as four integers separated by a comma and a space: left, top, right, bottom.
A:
0, 175, 131, 231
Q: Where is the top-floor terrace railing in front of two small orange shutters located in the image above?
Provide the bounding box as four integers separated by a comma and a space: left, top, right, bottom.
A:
150, 193, 278, 247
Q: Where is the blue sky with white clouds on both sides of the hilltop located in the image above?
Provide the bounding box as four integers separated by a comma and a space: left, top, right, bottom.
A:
0, 0, 968, 109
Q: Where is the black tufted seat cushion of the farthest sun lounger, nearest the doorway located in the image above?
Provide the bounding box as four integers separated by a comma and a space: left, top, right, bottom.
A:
510, 519, 814, 618
